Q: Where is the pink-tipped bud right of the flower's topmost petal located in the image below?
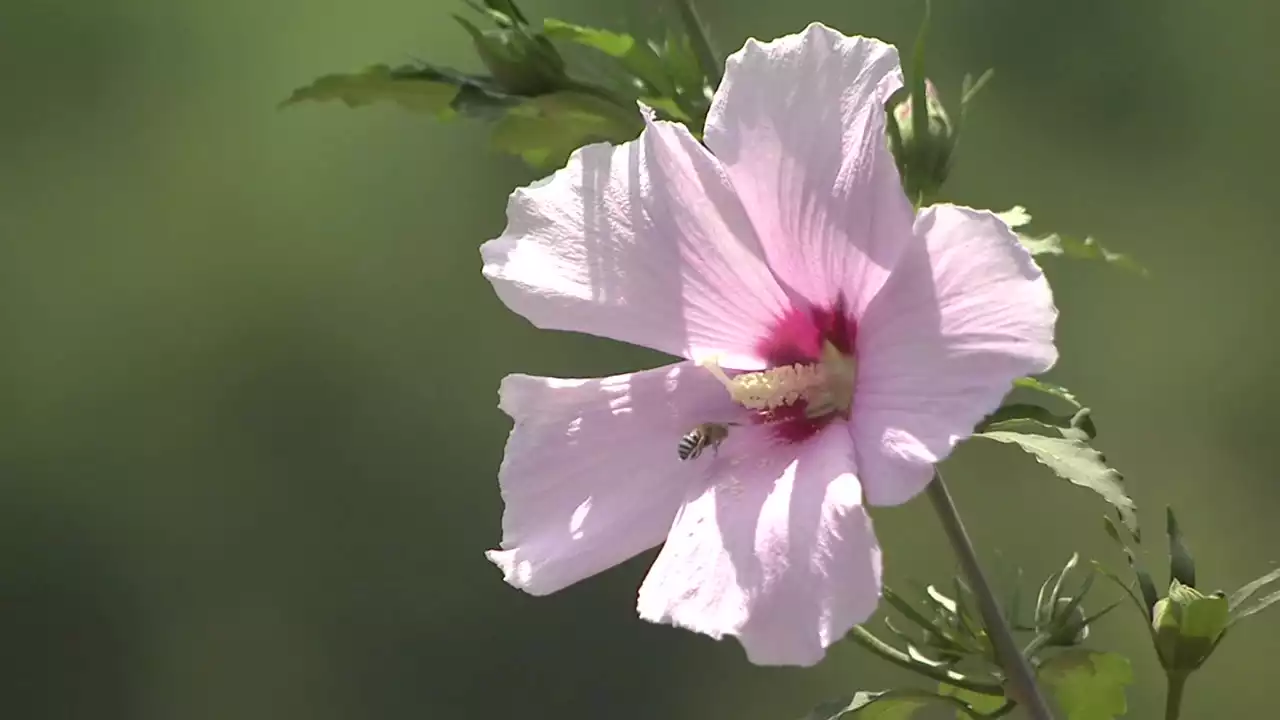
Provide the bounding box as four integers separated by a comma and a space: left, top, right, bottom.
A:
887, 79, 956, 201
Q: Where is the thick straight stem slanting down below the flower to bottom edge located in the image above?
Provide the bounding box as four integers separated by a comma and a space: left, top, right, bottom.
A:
928, 469, 1053, 720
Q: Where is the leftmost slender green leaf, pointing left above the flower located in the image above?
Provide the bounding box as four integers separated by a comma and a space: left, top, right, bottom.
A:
280, 65, 460, 115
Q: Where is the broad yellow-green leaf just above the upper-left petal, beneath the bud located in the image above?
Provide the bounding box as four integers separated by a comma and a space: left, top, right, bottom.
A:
493, 91, 644, 169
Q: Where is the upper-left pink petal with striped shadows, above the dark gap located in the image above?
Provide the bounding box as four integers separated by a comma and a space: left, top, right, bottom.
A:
481, 123, 787, 369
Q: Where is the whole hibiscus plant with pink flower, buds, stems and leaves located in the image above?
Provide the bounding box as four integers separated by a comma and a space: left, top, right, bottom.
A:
285, 0, 1280, 720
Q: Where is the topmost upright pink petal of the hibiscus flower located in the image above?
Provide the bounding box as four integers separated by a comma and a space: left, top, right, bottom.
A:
707, 23, 914, 311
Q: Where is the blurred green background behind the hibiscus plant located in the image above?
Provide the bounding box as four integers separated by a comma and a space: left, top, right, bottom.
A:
0, 0, 1280, 720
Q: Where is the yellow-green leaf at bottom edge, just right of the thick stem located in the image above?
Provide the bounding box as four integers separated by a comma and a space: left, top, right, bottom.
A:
1038, 648, 1133, 720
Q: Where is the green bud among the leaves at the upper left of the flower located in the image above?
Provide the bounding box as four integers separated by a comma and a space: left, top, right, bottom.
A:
454, 15, 568, 97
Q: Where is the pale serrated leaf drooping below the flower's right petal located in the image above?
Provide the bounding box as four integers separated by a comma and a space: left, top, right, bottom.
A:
974, 409, 1138, 533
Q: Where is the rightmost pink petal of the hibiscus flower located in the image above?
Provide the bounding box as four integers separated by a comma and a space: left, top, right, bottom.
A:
852, 205, 1057, 505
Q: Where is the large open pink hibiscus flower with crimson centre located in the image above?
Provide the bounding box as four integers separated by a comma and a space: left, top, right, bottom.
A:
481, 24, 1057, 665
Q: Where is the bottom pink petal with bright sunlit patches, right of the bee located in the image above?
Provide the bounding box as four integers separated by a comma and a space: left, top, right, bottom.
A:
639, 424, 881, 665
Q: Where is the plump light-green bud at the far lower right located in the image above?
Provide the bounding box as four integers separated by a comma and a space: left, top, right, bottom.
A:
1152, 579, 1231, 673
